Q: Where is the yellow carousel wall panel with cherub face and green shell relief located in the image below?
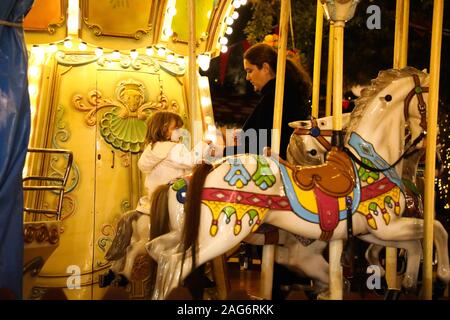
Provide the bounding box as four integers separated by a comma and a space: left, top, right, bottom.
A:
26, 52, 189, 299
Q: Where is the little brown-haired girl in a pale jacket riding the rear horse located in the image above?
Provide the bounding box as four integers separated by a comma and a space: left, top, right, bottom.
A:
136, 111, 214, 213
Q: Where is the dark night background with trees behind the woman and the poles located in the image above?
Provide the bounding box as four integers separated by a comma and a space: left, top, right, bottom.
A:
203, 0, 450, 230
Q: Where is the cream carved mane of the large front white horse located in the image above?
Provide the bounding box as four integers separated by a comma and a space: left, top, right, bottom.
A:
345, 67, 428, 140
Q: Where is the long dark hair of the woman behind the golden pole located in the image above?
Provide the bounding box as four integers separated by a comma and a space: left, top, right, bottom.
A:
244, 43, 312, 99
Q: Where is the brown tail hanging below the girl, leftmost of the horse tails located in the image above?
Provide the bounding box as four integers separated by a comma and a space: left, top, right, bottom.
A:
105, 210, 141, 261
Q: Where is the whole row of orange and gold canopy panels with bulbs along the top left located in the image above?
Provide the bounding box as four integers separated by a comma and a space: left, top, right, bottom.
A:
24, 0, 247, 56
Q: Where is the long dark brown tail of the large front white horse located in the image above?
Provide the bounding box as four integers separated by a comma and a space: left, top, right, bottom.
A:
181, 163, 213, 270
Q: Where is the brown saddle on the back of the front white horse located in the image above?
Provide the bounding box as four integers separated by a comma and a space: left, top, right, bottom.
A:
294, 147, 356, 198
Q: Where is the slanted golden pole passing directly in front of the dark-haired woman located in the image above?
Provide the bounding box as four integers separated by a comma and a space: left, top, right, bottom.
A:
261, 0, 291, 299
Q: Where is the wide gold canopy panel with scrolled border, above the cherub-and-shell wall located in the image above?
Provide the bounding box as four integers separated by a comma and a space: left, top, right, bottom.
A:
80, 0, 166, 49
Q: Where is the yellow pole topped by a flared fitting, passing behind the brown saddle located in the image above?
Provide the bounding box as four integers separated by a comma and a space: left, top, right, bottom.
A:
322, 0, 359, 300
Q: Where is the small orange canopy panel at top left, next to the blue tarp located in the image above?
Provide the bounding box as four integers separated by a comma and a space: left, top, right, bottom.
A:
23, 0, 67, 44
